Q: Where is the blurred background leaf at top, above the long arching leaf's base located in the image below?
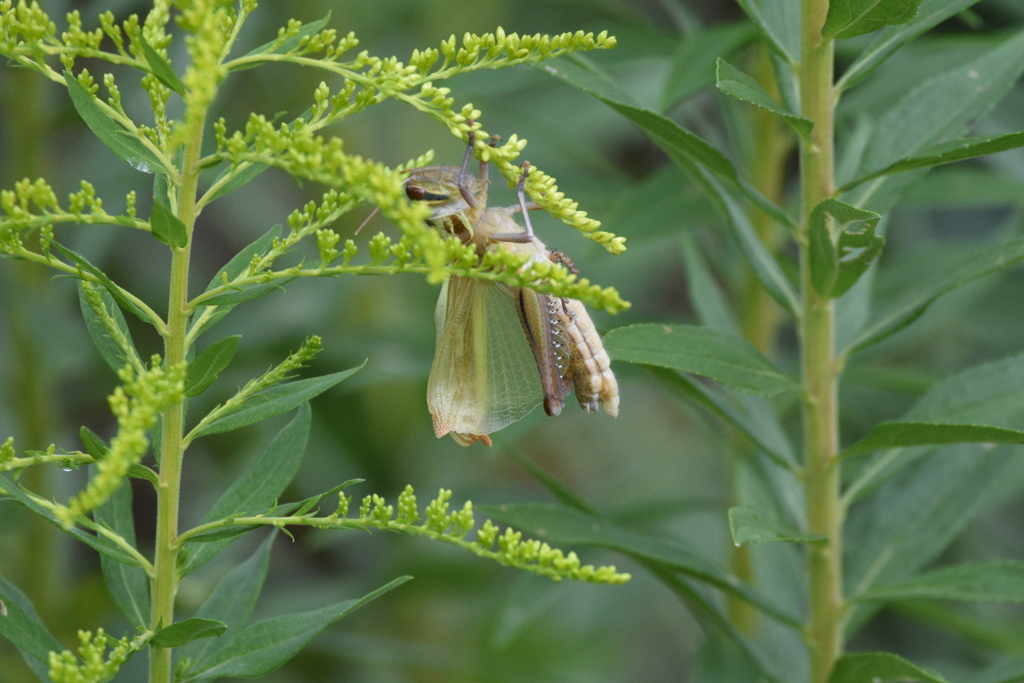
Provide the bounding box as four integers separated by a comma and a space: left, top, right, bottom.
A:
662, 22, 757, 112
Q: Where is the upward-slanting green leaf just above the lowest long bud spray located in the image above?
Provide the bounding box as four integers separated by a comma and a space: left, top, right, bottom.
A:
181, 403, 312, 577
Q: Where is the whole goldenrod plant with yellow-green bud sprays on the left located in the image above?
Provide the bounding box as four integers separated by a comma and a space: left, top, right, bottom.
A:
0, 0, 630, 683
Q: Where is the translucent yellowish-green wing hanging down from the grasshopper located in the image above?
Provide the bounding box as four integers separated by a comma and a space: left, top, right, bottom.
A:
427, 276, 543, 445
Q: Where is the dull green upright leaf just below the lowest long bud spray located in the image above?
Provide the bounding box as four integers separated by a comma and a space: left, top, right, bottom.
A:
176, 529, 278, 661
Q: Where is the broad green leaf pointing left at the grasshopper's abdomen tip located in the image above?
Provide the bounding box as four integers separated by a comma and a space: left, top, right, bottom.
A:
604, 324, 798, 396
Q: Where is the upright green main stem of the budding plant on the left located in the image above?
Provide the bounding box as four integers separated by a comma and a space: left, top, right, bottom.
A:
150, 113, 205, 683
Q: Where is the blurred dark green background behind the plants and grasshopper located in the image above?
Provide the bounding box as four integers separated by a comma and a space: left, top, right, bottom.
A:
6, 0, 1024, 683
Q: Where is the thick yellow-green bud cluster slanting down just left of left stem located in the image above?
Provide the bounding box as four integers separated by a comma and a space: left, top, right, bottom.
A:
55, 355, 185, 528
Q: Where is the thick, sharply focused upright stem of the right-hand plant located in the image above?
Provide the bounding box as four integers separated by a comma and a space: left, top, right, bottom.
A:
800, 0, 843, 683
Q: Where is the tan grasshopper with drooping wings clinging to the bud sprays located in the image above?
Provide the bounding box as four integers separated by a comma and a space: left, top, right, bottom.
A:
406, 132, 618, 445
